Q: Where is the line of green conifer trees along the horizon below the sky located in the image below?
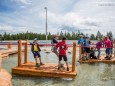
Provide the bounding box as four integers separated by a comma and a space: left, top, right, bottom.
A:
0, 31, 113, 40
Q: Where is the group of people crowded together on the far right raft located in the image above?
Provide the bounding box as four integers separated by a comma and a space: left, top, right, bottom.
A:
78, 35, 113, 60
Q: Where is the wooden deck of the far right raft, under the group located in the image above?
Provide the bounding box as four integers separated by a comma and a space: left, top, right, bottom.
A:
79, 55, 115, 63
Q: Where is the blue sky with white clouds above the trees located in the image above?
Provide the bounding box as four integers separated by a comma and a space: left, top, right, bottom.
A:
0, 0, 115, 34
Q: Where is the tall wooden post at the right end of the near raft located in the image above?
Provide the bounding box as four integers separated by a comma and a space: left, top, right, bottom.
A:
72, 42, 76, 72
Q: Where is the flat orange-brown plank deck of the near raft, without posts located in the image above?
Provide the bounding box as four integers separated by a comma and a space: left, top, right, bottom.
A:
12, 62, 77, 78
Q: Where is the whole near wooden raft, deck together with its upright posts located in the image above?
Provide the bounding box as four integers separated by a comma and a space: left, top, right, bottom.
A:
12, 40, 77, 78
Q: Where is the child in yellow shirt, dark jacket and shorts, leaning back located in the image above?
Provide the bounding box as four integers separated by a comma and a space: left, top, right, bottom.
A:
31, 38, 44, 67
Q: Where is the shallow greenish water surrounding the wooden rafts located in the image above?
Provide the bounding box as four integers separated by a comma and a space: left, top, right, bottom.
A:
3, 51, 115, 86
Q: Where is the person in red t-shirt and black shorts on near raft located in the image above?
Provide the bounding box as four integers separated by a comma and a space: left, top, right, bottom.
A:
56, 37, 69, 71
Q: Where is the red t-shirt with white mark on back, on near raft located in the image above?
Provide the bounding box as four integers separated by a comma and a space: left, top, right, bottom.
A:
56, 41, 68, 55
